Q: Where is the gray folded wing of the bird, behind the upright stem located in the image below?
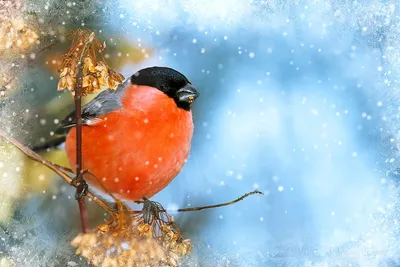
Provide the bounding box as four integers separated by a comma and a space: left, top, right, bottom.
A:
54, 79, 130, 135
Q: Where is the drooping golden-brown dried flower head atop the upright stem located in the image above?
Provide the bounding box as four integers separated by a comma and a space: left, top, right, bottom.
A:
57, 30, 124, 96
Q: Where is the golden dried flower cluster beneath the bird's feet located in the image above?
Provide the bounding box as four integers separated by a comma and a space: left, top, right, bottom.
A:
72, 202, 192, 267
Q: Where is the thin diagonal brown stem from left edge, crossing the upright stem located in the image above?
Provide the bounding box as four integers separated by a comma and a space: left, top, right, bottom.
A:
0, 130, 115, 220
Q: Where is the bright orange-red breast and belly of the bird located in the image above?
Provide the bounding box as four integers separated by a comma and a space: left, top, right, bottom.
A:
66, 85, 193, 200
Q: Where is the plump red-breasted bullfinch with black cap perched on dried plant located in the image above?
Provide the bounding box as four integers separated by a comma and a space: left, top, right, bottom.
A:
33, 66, 199, 201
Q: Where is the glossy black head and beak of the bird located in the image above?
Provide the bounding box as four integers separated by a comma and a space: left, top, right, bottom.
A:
131, 67, 199, 111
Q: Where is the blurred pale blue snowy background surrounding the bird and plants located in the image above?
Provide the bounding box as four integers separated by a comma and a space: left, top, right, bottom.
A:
0, 0, 400, 267
